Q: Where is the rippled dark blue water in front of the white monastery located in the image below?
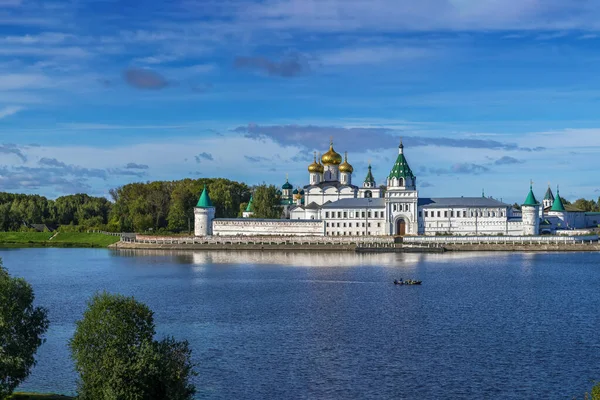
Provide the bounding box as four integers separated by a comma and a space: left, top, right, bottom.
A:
0, 249, 600, 399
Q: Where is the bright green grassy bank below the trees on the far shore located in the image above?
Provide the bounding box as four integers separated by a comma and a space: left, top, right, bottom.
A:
0, 232, 120, 248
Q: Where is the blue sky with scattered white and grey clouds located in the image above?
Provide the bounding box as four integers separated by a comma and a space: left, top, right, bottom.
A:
0, 0, 600, 203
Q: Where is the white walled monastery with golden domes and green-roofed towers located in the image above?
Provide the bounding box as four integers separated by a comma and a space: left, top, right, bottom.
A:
194, 141, 600, 236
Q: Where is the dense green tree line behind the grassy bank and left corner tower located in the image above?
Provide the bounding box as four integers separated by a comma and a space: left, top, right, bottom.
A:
0, 178, 281, 233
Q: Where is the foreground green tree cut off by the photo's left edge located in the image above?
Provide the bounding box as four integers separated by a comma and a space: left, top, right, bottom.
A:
0, 261, 49, 399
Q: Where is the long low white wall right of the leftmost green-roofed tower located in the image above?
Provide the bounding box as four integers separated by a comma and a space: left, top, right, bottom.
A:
213, 218, 325, 236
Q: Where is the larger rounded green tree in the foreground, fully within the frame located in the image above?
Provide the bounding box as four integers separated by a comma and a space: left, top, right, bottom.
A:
69, 293, 195, 400
